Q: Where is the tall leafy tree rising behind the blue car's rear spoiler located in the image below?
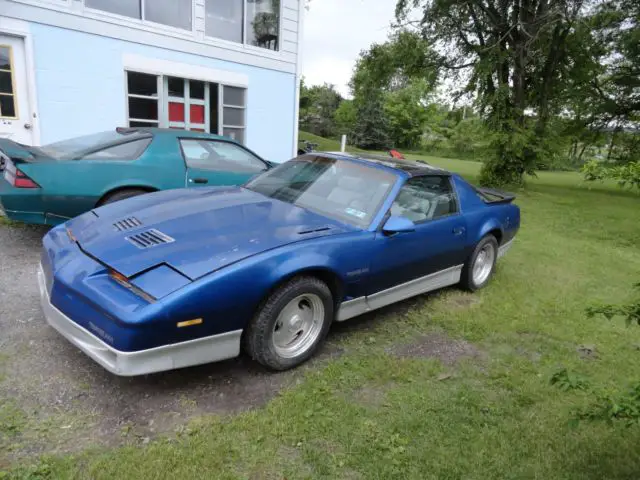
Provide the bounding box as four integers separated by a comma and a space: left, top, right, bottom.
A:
396, 0, 604, 184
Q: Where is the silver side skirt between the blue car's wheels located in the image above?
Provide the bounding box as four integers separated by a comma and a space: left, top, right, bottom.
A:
336, 265, 464, 322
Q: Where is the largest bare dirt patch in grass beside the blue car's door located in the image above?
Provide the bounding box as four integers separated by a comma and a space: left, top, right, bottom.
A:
391, 333, 481, 365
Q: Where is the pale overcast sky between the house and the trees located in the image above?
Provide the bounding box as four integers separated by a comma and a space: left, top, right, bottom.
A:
302, 0, 396, 95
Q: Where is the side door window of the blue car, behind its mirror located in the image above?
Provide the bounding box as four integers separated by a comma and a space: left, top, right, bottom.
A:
391, 175, 458, 223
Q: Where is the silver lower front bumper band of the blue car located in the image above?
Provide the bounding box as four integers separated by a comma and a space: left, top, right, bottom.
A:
38, 266, 242, 377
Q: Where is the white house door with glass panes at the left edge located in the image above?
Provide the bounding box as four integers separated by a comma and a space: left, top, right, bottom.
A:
0, 34, 34, 145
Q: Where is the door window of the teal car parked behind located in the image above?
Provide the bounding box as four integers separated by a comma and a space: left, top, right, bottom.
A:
180, 139, 267, 173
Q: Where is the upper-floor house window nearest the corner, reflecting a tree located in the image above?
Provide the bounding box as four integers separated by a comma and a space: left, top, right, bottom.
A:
205, 0, 280, 50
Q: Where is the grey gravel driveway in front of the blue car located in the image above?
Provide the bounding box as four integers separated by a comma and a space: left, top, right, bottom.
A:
0, 223, 335, 464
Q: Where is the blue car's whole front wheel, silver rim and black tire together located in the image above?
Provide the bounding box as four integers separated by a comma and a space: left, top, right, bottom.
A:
245, 276, 334, 370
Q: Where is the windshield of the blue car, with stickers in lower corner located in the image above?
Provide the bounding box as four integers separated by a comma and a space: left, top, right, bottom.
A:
246, 155, 396, 228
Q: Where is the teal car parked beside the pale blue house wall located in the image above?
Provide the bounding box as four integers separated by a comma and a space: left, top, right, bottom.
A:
0, 128, 272, 225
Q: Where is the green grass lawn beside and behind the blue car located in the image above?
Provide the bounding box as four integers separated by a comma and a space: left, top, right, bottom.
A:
5, 144, 640, 479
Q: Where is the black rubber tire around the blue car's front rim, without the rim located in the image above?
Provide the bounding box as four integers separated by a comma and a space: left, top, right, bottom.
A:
244, 276, 334, 371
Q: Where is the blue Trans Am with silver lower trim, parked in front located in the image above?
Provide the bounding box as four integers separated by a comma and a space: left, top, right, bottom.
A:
39, 153, 520, 375
